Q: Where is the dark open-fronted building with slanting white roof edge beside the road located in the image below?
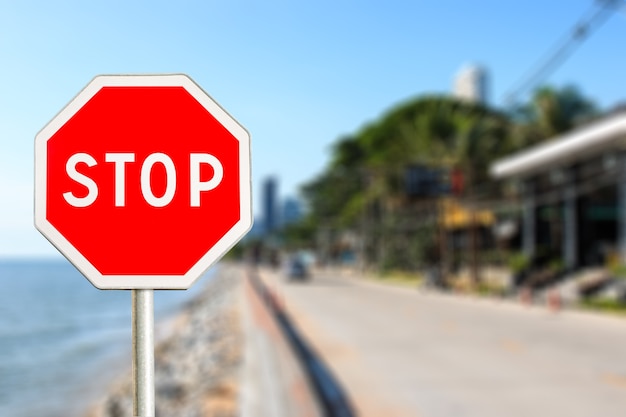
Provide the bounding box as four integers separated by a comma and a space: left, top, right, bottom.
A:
491, 112, 626, 270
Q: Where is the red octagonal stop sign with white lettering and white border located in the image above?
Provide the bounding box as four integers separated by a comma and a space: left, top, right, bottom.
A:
35, 75, 252, 289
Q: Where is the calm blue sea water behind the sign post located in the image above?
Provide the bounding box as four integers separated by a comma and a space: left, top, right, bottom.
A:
0, 258, 212, 417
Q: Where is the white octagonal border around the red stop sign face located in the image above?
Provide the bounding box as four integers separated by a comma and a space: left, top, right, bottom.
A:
34, 74, 253, 290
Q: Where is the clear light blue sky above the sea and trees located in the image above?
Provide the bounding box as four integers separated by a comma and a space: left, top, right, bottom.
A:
0, 0, 626, 256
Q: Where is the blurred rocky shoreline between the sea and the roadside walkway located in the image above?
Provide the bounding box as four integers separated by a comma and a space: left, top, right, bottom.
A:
85, 265, 243, 417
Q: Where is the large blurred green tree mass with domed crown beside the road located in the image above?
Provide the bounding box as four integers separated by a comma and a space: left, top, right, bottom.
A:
303, 96, 511, 270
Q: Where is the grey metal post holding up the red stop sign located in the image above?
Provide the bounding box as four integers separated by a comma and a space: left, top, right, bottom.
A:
132, 290, 155, 417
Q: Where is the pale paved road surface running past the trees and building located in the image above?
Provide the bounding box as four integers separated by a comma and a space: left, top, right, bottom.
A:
262, 271, 626, 417
